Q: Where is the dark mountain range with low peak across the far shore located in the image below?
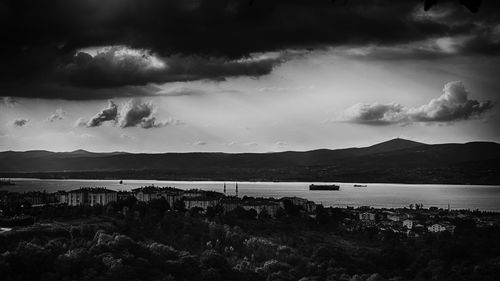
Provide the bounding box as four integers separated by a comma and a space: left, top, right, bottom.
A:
0, 138, 500, 184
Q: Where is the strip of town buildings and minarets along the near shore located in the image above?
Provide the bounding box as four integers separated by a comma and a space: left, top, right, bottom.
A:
0, 184, 500, 238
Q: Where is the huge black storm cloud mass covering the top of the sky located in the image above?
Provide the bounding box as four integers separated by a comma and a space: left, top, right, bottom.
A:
0, 0, 499, 99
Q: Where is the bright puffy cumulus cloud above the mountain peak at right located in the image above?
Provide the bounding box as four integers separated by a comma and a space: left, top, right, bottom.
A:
343, 81, 493, 125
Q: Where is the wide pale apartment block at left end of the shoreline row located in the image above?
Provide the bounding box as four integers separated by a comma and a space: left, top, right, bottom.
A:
68, 187, 118, 206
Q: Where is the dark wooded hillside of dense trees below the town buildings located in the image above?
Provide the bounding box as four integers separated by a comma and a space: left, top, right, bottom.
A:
0, 199, 500, 280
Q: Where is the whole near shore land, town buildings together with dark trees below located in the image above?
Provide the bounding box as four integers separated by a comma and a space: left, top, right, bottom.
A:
0, 185, 500, 281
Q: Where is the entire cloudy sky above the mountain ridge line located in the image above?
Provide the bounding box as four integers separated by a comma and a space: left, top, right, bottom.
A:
0, 0, 500, 152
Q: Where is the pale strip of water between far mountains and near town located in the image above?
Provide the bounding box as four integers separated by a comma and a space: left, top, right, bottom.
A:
1, 179, 500, 212
